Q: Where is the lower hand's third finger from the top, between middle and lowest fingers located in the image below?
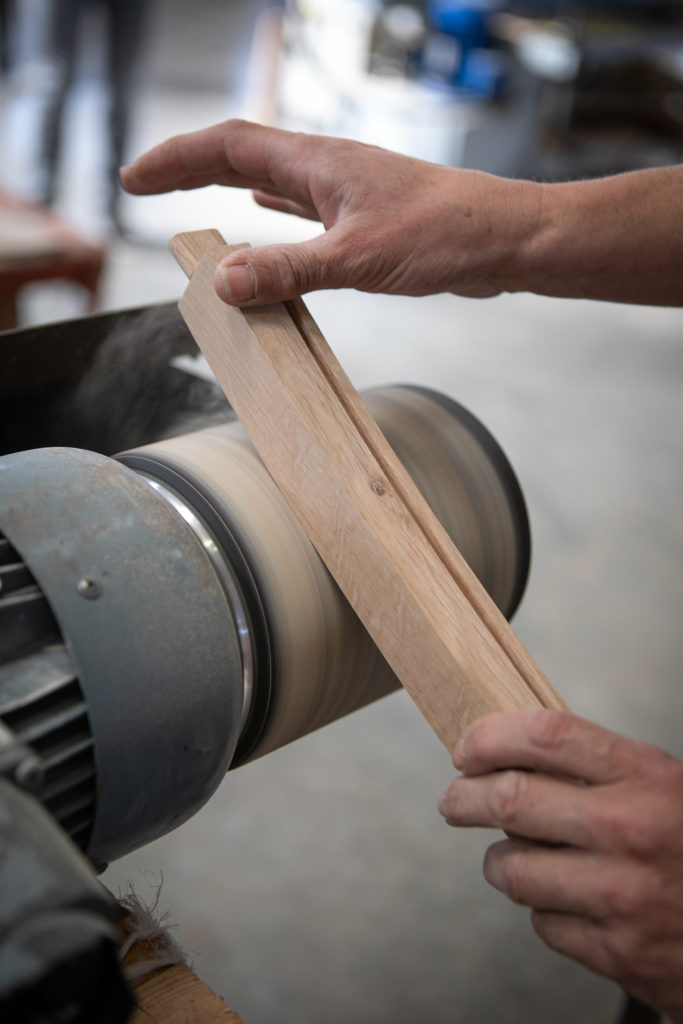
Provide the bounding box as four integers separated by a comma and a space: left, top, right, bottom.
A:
483, 839, 622, 921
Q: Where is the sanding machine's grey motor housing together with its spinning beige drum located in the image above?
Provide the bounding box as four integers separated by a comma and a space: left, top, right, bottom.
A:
0, 387, 529, 864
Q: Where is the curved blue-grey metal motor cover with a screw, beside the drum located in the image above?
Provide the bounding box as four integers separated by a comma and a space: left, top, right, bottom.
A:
0, 449, 243, 864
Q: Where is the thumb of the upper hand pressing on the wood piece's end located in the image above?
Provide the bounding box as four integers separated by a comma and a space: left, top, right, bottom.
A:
214, 236, 339, 306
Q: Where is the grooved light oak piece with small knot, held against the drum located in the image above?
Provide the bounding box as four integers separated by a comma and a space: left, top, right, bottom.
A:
171, 232, 564, 749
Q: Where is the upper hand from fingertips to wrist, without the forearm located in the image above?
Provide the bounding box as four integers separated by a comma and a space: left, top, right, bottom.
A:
121, 121, 537, 306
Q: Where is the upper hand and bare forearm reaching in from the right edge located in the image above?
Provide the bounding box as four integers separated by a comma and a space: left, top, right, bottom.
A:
121, 121, 683, 306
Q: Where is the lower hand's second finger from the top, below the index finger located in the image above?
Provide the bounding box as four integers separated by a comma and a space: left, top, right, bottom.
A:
439, 770, 596, 849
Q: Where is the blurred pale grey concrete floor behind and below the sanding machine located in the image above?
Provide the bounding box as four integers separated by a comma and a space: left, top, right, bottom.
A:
2, 5, 683, 1024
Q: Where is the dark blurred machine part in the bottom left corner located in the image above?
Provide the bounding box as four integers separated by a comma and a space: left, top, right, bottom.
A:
0, 778, 134, 1024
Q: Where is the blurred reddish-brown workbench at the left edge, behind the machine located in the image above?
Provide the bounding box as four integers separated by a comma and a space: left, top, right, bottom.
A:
0, 193, 105, 323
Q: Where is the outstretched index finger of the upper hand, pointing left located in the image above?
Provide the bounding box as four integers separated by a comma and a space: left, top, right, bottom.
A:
121, 121, 294, 196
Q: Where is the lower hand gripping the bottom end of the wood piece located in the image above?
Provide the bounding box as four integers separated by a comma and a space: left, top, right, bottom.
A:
439, 710, 683, 1021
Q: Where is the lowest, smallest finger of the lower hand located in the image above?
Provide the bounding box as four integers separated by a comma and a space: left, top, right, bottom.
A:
531, 910, 620, 979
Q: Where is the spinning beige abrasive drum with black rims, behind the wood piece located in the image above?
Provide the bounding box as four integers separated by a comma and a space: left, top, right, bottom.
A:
119, 386, 529, 764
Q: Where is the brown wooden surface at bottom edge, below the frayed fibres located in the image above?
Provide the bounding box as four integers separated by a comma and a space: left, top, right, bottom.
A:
129, 964, 244, 1024
